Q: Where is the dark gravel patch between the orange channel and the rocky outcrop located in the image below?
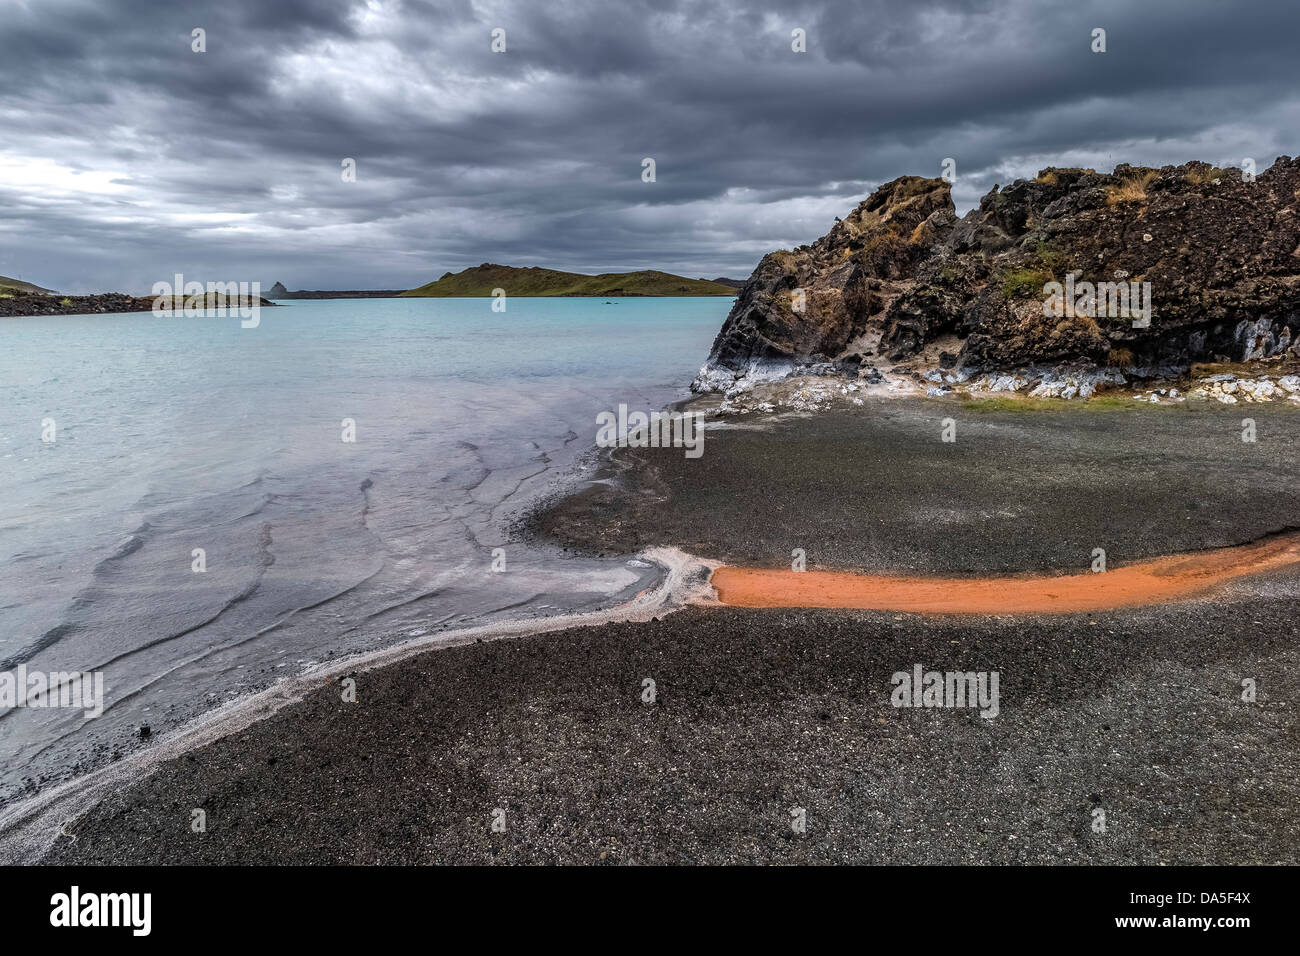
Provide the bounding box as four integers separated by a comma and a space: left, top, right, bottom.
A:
540, 399, 1300, 574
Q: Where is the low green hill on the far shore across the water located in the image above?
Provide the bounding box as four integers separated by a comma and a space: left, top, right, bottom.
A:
402, 263, 736, 298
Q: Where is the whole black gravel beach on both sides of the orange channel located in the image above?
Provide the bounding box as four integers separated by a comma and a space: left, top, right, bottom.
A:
38, 399, 1300, 864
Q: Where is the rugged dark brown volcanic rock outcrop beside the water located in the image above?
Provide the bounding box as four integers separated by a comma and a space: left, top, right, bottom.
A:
693, 156, 1300, 392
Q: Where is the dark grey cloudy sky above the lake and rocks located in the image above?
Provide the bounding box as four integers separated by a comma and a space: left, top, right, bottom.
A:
0, 0, 1300, 293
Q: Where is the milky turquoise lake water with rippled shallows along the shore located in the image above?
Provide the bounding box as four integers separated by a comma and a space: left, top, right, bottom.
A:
0, 298, 732, 800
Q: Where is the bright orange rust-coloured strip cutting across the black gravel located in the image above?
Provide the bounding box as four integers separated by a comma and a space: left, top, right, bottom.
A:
712, 533, 1300, 614
